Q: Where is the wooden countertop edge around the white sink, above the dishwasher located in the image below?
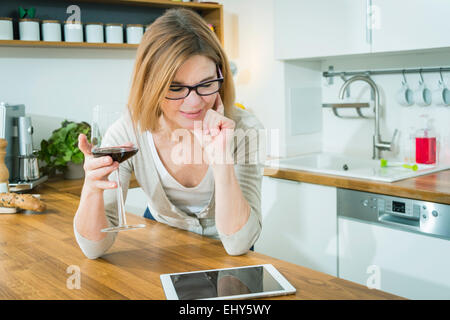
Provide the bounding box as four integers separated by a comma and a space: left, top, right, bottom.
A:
264, 167, 450, 204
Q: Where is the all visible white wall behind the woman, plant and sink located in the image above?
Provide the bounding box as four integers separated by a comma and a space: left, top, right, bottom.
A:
0, 0, 450, 161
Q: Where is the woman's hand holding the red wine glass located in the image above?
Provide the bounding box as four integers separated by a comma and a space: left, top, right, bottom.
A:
78, 134, 119, 192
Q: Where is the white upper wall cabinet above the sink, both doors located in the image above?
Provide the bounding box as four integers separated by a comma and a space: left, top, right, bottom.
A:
274, 0, 450, 60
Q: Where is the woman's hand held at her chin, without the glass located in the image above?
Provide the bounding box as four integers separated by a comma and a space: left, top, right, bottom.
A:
194, 93, 235, 165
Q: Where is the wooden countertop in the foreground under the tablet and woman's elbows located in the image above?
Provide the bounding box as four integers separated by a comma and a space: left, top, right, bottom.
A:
0, 181, 400, 299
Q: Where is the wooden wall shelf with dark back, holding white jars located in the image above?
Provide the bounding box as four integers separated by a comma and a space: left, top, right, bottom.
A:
0, 0, 224, 49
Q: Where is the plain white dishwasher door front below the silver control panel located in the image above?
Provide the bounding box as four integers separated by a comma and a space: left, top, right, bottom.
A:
338, 217, 450, 299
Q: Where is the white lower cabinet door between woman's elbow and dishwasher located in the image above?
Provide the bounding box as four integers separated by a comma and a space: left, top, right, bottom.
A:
255, 177, 337, 276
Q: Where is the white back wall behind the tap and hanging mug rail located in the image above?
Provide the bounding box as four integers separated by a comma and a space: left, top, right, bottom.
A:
322, 52, 450, 163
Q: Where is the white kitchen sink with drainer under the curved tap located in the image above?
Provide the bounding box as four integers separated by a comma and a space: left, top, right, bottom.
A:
266, 153, 450, 182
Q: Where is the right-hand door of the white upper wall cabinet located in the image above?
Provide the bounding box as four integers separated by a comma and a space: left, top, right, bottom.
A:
372, 0, 450, 52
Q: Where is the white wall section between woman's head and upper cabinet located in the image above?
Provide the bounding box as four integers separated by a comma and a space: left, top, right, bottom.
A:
220, 0, 286, 153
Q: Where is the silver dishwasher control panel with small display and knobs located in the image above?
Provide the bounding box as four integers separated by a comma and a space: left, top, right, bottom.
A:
337, 188, 450, 239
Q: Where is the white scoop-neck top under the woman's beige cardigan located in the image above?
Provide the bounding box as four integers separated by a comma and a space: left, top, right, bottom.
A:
147, 132, 214, 215
